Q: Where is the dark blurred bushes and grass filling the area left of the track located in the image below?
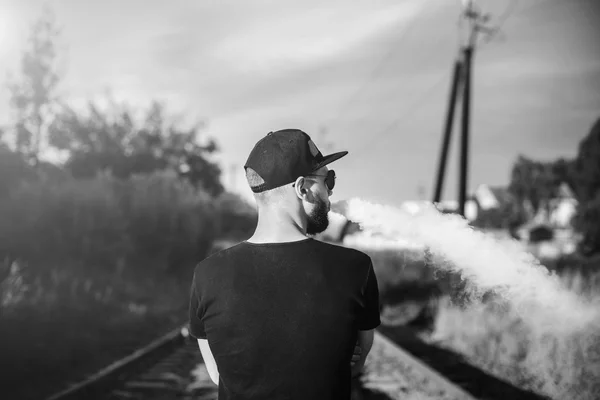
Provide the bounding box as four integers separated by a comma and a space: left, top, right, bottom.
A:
0, 171, 256, 399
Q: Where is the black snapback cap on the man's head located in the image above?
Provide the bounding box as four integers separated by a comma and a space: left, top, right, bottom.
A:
244, 129, 348, 193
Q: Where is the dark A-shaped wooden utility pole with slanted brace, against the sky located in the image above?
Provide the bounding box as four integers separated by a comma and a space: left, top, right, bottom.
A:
433, 0, 491, 216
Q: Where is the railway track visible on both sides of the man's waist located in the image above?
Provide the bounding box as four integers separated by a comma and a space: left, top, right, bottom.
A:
46, 326, 545, 400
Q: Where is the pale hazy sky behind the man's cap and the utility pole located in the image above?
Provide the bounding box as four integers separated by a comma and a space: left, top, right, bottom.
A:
0, 0, 600, 205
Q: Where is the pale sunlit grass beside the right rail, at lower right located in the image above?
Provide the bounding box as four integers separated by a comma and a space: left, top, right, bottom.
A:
430, 264, 600, 400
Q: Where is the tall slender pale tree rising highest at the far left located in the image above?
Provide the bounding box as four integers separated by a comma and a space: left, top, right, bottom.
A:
8, 7, 59, 165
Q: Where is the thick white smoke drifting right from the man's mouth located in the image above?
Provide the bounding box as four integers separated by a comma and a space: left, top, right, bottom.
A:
347, 199, 598, 333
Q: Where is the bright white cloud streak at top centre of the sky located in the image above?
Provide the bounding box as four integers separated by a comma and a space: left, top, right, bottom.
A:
209, 1, 423, 74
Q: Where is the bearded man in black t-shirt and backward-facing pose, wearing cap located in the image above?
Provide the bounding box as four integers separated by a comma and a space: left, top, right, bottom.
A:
190, 129, 380, 400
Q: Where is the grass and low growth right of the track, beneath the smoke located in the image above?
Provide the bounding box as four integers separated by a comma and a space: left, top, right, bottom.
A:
350, 241, 600, 400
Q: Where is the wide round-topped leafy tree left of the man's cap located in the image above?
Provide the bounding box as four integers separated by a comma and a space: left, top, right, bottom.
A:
49, 101, 224, 196
